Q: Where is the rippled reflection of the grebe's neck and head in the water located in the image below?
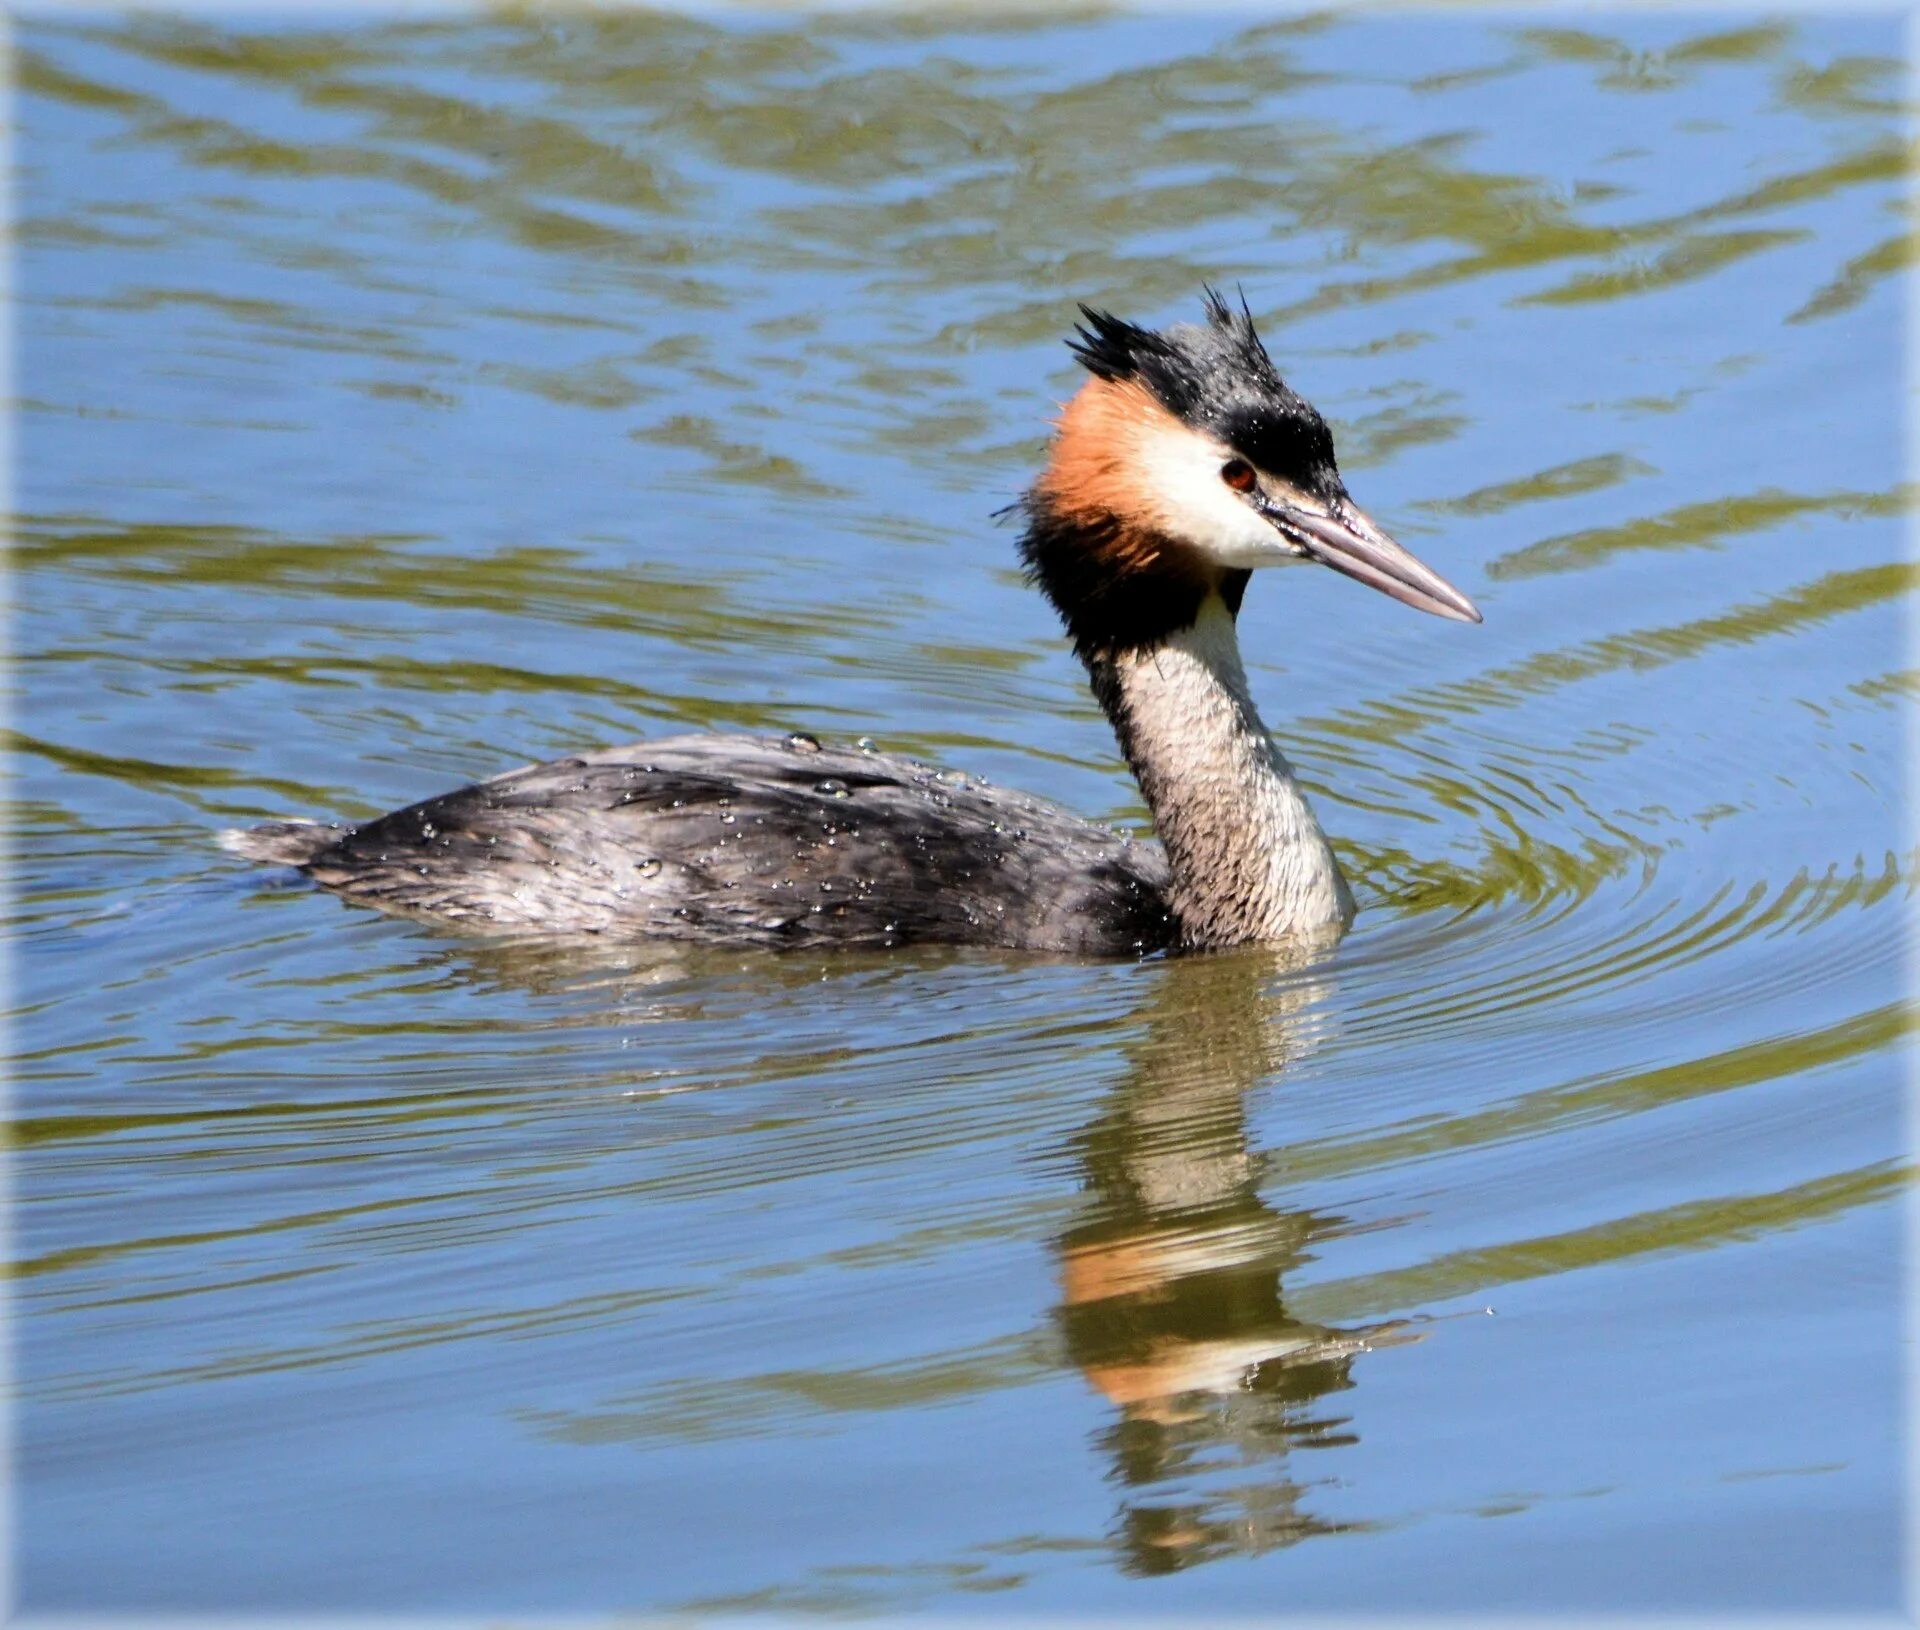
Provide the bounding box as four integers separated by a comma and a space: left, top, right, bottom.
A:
1058, 950, 1409, 1572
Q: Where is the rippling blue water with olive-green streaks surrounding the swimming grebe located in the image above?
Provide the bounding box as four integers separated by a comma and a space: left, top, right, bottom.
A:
8, 12, 1920, 1618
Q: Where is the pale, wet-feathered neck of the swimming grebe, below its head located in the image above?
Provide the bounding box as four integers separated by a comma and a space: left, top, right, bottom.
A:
1081, 593, 1354, 947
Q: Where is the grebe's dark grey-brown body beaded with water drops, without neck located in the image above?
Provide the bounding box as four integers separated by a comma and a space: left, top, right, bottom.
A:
230, 735, 1177, 954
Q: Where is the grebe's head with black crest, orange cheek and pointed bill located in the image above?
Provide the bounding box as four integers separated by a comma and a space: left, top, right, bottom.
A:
1021, 290, 1480, 649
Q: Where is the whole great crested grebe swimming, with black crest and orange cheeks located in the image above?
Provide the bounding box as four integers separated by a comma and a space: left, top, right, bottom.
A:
223, 290, 1480, 954
